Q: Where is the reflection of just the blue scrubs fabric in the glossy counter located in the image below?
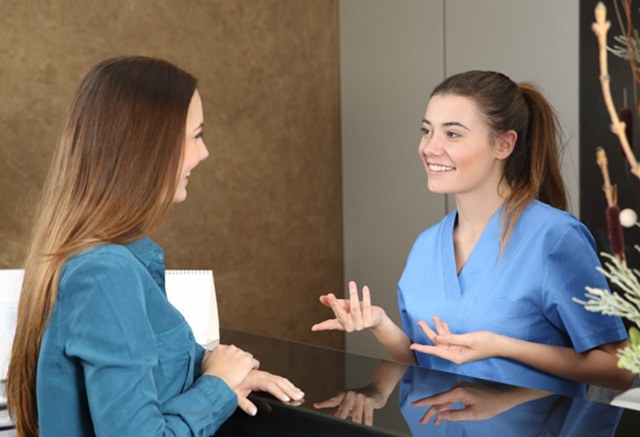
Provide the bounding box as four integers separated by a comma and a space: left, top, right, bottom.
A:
400, 367, 623, 437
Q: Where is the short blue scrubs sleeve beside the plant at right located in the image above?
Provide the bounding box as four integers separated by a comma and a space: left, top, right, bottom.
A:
542, 222, 627, 352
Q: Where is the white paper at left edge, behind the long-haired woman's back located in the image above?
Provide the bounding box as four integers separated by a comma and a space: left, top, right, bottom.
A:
0, 269, 24, 380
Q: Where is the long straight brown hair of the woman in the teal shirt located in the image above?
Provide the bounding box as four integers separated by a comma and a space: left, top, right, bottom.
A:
6, 56, 196, 436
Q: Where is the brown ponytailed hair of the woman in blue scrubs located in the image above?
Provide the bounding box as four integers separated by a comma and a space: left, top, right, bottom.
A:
431, 70, 567, 249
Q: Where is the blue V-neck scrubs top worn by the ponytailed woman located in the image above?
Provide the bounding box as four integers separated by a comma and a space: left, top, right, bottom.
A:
398, 201, 626, 396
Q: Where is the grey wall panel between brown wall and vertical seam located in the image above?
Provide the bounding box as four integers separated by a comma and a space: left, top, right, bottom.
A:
335, 0, 445, 356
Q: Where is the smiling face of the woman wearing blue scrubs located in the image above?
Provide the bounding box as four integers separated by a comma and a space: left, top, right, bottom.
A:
418, 94, 516, 199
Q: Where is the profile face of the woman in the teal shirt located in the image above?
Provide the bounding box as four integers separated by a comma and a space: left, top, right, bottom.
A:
173, 91, 209, 202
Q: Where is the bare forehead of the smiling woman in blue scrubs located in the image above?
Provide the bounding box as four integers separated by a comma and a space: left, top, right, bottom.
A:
425, 94, 484, 126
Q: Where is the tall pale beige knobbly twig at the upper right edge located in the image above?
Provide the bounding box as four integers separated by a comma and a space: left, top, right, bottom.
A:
591, 2, 640, 179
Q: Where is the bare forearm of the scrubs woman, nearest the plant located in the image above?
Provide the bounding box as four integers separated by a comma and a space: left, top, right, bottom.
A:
498, 336, 633, 390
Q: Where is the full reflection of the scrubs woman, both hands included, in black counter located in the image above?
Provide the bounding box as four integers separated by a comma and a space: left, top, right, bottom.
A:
313, 361, 622, 436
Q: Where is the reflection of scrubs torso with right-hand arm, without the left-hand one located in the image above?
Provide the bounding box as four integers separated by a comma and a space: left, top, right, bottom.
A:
400, 367, 623, 436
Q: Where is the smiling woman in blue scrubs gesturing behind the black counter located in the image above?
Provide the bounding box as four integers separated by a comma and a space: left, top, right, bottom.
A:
312, 71, 633, 396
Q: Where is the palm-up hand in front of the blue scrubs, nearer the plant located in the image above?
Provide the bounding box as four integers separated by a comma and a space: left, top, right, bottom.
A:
410, 316, 501, 364
